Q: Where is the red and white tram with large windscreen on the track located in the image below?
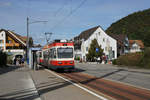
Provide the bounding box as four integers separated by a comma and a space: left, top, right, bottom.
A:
37, 40, 74, 70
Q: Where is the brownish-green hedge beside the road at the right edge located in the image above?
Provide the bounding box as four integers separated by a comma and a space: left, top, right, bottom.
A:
113, 48, 150, 68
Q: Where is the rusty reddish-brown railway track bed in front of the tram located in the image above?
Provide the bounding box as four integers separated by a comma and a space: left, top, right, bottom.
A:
59, 72, 150, 100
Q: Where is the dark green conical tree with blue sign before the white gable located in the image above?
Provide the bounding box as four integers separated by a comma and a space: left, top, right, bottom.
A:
86, 39, 103, 61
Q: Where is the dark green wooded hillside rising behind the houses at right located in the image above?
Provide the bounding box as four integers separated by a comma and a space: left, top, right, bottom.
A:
106, 9, 150, 47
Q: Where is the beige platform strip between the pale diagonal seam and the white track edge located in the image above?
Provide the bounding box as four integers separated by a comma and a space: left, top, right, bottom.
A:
30, 69, 100, 100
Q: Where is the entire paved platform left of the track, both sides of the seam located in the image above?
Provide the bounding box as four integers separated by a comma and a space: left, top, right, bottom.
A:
0, 66, 102, 100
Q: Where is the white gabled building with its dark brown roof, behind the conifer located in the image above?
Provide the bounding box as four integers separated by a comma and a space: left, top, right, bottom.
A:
74, 26, 117, 61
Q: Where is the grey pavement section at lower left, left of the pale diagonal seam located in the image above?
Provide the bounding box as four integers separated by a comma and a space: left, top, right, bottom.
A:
0, 66, 41, 100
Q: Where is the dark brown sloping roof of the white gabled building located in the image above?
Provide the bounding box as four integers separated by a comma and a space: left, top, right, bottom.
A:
74, 26, 100, 40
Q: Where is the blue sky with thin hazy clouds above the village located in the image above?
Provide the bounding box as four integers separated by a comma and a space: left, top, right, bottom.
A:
0, 0, 150, 45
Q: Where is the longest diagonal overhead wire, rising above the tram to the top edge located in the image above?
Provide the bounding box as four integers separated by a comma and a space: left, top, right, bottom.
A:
51, 0, 87, 30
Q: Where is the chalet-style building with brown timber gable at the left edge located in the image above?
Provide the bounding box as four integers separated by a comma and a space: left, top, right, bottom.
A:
0, 29, 33, 54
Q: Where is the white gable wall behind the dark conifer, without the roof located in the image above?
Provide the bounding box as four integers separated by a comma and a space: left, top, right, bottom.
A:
81, 27, 117, 59
